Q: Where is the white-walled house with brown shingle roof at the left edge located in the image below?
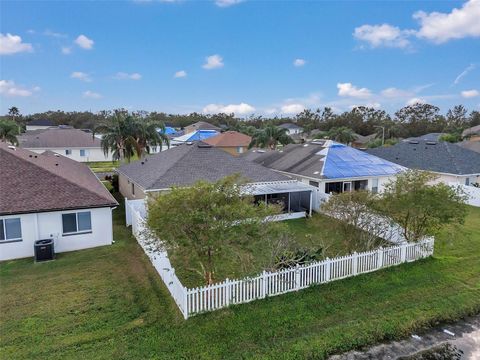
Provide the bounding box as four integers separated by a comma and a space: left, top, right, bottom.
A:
0, 142, 118, 261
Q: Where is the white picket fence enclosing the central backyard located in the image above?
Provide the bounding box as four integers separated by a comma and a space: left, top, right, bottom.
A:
125, 200, 434, 319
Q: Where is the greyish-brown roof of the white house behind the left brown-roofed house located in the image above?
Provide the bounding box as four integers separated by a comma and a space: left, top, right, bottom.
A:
18, 127, 101, 149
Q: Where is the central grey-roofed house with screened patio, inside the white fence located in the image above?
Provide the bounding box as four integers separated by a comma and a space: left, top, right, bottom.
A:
117, 142, 316, 218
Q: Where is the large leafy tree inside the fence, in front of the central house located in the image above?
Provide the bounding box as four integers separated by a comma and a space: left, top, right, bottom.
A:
147, 175, 286, 284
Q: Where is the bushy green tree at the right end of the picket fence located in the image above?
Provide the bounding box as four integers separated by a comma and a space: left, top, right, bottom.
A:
378, 170, 467, 241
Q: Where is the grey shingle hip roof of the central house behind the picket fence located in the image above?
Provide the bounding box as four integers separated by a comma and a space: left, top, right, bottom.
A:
118, 142, 290, 190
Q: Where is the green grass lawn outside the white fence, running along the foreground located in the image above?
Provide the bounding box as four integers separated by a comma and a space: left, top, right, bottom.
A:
0, 198, 480, 359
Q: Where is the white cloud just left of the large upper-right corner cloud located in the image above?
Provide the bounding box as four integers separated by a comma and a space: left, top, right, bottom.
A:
353, 24, 412, 48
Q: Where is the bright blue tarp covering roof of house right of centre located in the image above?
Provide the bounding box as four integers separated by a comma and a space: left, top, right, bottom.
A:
322, 142, 405, 179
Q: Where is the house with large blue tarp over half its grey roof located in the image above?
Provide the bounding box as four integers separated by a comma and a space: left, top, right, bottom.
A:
246, 140, 405, 194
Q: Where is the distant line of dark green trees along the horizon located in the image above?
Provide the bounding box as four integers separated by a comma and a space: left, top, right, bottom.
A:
0, 103, 480, 139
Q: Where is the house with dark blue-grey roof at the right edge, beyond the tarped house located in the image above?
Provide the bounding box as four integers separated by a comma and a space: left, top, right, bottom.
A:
367, 140, 480, 185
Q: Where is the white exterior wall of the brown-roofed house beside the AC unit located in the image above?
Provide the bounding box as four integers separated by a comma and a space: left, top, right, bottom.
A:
0, 207, 113, 261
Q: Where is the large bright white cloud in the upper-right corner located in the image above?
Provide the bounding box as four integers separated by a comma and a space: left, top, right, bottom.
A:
413, 0, 480, 44
